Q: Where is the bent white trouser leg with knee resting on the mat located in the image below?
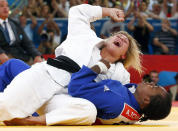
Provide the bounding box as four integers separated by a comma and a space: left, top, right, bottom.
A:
38, 94, 97, 125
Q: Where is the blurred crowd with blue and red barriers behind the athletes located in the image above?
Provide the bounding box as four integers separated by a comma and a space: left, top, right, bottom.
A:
4, 0, 178, 100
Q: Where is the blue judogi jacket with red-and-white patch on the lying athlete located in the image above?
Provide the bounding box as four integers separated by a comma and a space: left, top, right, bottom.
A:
68, 66, 140, 124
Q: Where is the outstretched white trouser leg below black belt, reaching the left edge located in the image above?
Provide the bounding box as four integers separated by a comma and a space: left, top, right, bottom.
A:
0, 63, 63, 121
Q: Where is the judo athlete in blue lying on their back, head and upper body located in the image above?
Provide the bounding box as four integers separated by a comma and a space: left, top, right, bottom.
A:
68, 59, 171, 124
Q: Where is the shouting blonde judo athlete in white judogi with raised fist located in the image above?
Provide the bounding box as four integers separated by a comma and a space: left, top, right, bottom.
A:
0, 4, 141, 125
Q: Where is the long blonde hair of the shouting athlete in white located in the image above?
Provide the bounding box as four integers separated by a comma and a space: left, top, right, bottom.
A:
112, 31, 143, 74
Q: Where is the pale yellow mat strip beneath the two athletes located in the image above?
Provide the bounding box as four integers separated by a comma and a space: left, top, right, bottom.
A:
0, 107, 178, 131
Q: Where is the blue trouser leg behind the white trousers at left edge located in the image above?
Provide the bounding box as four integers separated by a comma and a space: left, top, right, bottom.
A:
0, 59, 30, 92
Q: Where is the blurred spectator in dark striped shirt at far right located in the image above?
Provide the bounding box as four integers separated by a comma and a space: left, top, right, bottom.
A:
153, 19, 178, 54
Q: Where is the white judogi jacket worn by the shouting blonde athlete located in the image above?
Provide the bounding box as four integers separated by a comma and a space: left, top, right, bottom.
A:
47, 4, 130, 86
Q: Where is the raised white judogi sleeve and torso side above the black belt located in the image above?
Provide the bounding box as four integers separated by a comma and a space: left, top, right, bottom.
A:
55, 4, 102, 66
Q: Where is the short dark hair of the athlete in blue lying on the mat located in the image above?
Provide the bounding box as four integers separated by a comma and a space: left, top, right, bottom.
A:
140, 92, 172, 121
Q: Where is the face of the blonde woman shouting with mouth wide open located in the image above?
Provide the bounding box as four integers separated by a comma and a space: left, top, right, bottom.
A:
101, 34, 129, 63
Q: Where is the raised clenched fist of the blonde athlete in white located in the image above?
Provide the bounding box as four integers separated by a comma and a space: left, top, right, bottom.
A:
109, 8, 125, 22
